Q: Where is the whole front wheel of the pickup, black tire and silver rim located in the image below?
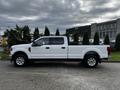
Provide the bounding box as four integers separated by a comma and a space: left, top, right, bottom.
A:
13, 54, 28, 67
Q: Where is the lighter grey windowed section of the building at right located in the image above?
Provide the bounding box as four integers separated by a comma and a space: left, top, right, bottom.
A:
91, 19, 120, 40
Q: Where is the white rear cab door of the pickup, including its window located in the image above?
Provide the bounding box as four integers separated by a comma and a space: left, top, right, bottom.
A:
49, 37, 67, 59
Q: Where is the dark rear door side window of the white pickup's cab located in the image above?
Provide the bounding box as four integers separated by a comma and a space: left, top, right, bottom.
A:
49, 38, 64, 45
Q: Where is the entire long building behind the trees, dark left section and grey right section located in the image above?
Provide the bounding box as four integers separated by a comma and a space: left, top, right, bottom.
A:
66, 19, 120, 41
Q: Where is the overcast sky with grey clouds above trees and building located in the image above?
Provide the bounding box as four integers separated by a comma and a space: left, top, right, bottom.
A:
0, 0, 120, 33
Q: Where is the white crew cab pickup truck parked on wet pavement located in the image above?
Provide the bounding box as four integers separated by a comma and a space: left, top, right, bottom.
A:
10, 36, 110, 67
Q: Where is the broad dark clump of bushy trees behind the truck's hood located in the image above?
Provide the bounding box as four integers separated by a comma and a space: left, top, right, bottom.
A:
3, 25, 31, 47
